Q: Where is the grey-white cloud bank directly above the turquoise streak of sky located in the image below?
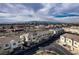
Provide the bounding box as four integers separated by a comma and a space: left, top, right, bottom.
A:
38, 3, 79, 16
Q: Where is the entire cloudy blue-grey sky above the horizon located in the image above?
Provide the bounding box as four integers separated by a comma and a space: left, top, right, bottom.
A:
0, 3, 79, 23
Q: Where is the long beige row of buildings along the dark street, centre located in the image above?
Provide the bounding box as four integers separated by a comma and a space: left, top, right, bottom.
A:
20, 30, 53, 45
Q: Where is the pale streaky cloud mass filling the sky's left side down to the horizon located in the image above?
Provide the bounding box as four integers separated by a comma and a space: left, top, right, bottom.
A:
0, 4, 38, 23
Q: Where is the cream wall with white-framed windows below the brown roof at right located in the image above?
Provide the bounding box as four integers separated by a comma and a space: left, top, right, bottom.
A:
60, 36, 79, 54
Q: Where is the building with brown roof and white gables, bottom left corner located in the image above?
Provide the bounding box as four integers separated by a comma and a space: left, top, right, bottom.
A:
0, 36, 21, 52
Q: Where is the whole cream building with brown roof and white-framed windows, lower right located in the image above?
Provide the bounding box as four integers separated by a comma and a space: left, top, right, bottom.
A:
60, 33, 79, 54
